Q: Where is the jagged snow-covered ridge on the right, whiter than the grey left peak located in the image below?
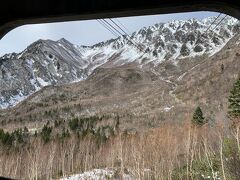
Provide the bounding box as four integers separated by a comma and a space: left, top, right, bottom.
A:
84, 16, 239, 65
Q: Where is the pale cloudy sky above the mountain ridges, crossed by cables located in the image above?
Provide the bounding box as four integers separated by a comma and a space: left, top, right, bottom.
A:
0, 11, 219, 56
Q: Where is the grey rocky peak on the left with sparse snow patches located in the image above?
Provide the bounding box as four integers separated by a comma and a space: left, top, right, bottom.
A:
0, 39, 87, 108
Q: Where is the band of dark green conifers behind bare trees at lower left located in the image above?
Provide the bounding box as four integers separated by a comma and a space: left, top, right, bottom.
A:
0, 116, 119, 146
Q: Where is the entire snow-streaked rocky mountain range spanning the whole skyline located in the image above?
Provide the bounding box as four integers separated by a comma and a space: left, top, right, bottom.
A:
0, 17, 239, 109
